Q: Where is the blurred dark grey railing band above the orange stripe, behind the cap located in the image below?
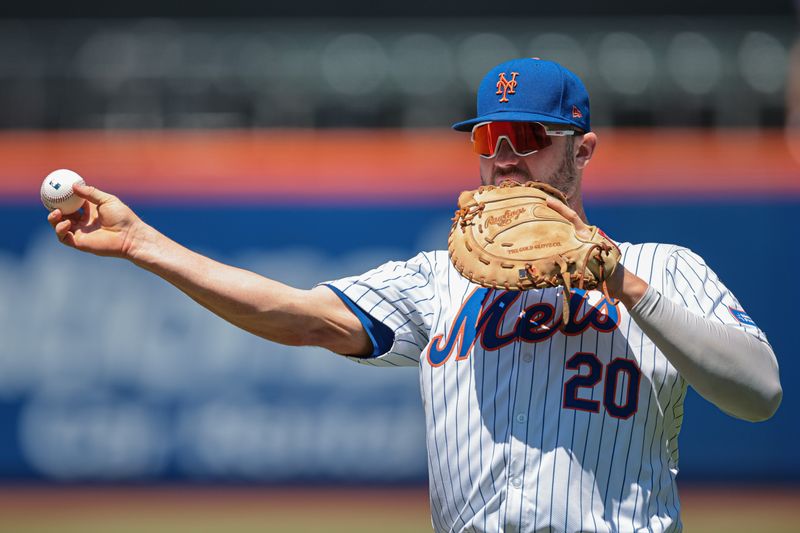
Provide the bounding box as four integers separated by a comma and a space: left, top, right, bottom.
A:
0, 17, 797, 129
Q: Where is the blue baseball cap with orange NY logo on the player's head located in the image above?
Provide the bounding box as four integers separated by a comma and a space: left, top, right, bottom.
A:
453, 58, 591, 133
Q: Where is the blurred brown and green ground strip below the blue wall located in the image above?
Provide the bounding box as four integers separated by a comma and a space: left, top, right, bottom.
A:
0, 486, 800, 533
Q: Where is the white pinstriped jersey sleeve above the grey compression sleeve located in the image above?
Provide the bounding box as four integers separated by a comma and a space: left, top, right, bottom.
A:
664, 248, 768, 342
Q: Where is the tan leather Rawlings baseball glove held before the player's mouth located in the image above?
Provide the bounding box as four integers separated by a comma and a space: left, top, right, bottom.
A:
448, 181, 620, 325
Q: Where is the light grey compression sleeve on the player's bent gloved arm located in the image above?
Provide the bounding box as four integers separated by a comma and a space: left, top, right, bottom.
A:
629, 287, 782, 421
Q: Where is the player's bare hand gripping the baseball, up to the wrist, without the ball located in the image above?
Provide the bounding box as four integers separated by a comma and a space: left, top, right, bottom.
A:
47, 183, 144, 257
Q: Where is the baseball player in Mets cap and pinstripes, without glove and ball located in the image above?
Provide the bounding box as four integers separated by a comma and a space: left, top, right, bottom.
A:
49, 59, 782, 533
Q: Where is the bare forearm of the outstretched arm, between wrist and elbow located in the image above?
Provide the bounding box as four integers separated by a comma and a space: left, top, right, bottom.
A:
126, 220, 315, 345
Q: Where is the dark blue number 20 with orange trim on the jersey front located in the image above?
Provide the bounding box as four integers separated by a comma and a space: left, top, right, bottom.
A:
564, 352, 642, 418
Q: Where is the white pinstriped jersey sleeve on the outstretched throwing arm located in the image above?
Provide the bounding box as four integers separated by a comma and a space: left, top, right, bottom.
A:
324, 252, 440, 366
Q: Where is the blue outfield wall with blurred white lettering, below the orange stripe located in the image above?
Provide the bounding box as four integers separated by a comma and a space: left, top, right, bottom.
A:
0, 199, 800, 482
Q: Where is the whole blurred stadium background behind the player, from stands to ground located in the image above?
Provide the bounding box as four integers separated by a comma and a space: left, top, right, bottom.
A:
0, 0, 800, 532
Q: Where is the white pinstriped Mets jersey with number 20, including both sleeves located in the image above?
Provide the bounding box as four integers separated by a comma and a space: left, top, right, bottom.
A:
324, 243, 766, 533
